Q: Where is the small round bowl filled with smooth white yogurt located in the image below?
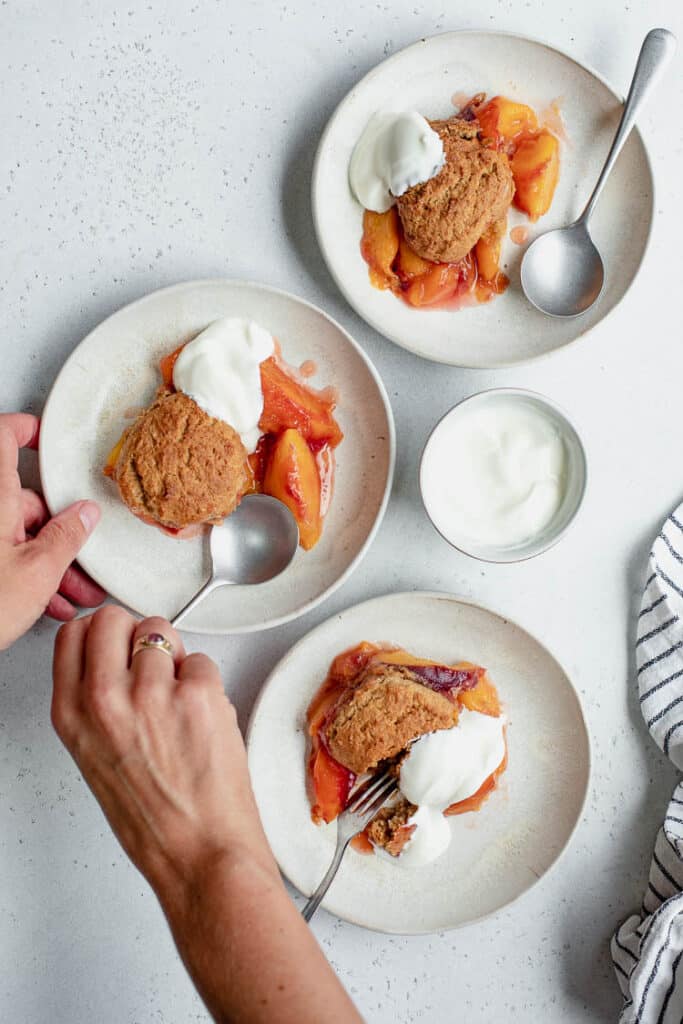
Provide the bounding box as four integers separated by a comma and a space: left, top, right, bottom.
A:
420, 388, 587, 562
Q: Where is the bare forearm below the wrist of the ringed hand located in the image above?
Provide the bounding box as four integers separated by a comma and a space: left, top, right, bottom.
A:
161, 855, 360, 1024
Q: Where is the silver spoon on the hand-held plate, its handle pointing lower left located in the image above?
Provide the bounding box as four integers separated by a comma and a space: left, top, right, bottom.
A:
171, 495, 299, 626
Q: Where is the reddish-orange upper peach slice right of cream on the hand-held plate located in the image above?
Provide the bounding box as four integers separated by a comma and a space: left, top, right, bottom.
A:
258, 356, 344, 447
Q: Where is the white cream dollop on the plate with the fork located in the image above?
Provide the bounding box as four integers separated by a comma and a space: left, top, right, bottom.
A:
382, 708, 506, 867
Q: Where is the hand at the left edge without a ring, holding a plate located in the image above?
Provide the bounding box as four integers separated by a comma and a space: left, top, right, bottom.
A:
0, 413, 105, 650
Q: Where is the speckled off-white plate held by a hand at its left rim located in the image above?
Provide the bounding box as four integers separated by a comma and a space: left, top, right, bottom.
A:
40, 281, 395, 634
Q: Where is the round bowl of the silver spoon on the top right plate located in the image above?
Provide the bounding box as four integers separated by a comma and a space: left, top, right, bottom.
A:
521, 221, 605, 316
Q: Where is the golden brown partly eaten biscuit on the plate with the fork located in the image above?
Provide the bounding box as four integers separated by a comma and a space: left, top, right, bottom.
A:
325, 665, 458, 775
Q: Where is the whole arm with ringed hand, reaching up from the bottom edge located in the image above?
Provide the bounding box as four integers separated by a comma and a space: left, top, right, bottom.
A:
52, 605, 360, 1024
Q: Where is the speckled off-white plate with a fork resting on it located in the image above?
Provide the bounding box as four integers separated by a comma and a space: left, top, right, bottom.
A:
247, 593, 590, 934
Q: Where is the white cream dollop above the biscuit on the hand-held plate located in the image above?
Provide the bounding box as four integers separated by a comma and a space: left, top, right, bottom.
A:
173, 316, 274, 452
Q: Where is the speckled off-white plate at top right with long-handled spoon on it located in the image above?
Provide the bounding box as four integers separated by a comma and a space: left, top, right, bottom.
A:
312, 32, 654, 369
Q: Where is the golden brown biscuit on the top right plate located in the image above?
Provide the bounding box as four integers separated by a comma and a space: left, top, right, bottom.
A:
396, 118, 514, 263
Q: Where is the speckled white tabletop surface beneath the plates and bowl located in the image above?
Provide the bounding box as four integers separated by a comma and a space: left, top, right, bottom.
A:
0, 0, 683, 1024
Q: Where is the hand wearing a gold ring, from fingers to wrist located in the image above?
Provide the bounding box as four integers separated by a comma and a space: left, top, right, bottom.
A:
52, 605, 278, 899
